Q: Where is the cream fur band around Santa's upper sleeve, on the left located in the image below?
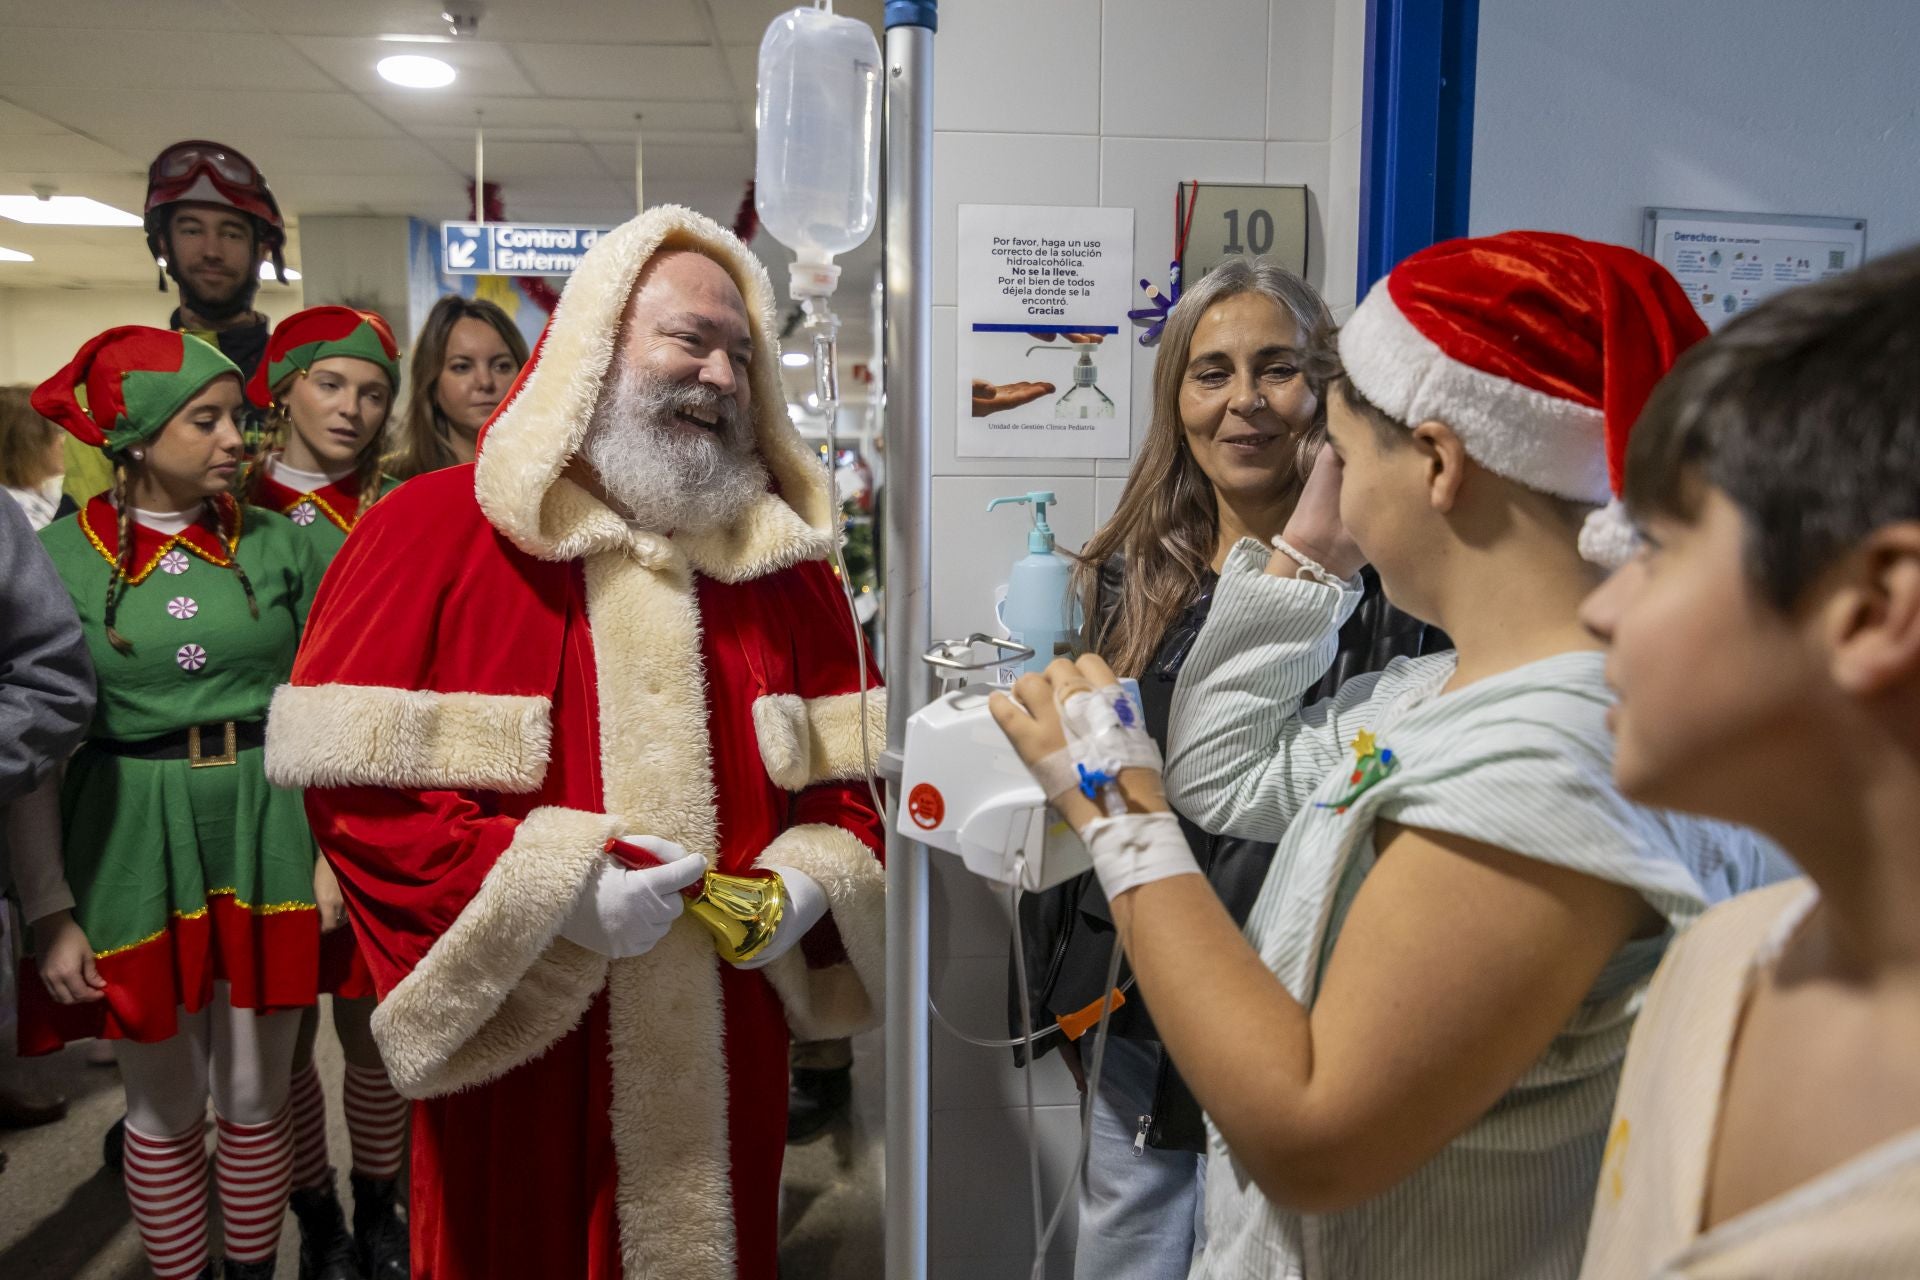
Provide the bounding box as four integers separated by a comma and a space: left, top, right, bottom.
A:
267, 685, 553, 794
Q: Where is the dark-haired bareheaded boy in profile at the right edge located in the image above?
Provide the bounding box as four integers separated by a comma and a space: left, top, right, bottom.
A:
1582, 249, 1920, 1280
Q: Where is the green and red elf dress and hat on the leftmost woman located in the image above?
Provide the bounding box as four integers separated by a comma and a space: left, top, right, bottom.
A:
19, 326, 324, 1054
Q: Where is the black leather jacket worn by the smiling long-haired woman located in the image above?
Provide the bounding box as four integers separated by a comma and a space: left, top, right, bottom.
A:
1006, 558, 1450, 1151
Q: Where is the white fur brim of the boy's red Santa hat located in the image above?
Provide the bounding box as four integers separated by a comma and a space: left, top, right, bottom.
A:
1340, 280, 1611, 505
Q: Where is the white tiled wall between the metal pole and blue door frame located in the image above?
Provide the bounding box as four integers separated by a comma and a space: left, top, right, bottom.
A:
927, 0, 1365, 1280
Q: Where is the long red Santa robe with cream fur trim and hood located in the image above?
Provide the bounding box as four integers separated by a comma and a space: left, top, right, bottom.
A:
267, 207, 885, 1280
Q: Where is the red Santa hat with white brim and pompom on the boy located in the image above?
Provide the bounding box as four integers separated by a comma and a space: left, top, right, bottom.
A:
1340, 230, 1707, 566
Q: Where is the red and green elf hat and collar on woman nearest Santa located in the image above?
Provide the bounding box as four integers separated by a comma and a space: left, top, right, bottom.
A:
248, 307, 399, 564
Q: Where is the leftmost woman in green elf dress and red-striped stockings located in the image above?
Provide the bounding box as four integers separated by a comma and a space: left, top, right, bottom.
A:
13, 326, 324, 1280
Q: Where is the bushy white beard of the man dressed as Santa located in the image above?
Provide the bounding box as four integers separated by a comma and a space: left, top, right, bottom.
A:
580, 367, 766, 533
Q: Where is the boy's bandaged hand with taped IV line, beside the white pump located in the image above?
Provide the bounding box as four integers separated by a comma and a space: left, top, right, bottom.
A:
989, 654, 1200, 900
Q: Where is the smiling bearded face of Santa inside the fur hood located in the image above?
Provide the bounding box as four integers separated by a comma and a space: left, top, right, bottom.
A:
580, 249, 766, 533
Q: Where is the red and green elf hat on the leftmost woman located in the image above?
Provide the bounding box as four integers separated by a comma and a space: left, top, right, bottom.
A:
33, 324, 240, 453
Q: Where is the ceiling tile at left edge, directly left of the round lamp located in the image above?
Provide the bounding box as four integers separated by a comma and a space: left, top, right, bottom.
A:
0, 29, 332, 98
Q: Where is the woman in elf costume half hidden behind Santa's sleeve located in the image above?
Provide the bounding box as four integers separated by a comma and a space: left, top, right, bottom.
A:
248, 307, 407, 1280
